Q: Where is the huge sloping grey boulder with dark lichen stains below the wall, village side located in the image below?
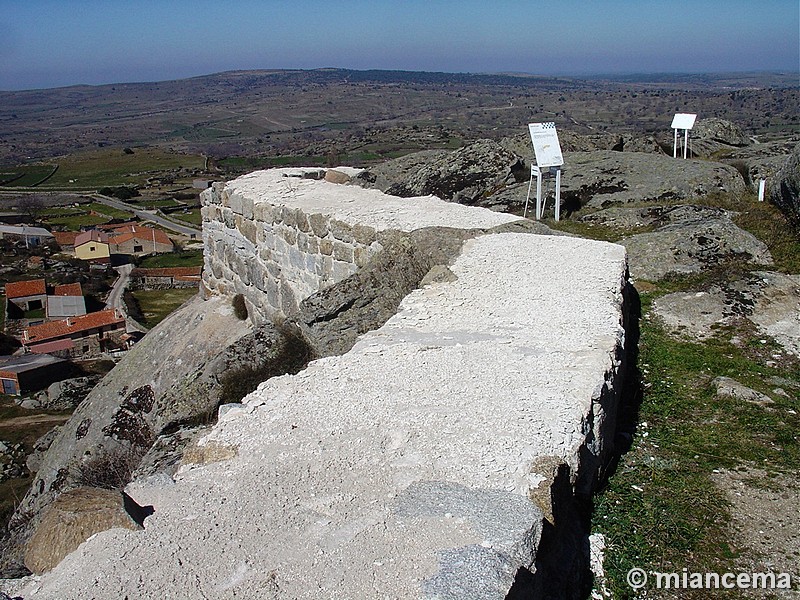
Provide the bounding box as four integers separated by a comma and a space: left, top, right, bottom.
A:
0, 297, 268, 572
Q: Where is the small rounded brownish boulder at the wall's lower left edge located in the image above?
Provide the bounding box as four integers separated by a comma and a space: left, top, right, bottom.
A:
25, 487, 142, 574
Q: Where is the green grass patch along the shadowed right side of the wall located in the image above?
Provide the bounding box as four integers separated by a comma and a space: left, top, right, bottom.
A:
592, 319, 800, 598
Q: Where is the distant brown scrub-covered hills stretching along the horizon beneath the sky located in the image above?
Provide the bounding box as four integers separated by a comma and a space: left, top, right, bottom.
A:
0, 68, 799, 164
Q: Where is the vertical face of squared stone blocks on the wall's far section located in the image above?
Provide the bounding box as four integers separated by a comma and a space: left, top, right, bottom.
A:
202, 178, 381, 323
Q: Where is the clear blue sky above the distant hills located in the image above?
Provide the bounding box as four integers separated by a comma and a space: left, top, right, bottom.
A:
0, 0, 800, 90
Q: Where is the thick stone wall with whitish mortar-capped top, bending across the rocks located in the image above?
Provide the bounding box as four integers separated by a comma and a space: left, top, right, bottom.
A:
8, 170, 627, 599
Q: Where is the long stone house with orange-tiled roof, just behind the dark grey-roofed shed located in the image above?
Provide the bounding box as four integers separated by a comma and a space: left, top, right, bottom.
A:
22, 308, 126, 358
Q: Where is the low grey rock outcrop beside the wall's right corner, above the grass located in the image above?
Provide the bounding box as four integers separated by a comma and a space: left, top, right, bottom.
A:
620, 206, 772, 281
